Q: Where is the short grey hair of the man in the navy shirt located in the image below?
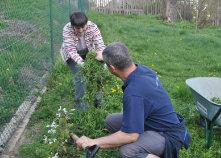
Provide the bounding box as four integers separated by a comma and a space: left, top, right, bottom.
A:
102, 42, 133, 70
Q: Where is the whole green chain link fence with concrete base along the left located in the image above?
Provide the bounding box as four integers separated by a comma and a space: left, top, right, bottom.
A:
0, 0, 81, 148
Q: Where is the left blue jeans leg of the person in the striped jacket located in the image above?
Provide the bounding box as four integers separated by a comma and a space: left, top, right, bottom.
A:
67, 59, 87, 110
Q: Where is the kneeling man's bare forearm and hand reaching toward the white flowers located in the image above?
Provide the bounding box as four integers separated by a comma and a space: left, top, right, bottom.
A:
76, 131, 139, 148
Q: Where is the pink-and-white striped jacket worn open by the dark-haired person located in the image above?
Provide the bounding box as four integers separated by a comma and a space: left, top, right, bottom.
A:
60, 21, 105, 64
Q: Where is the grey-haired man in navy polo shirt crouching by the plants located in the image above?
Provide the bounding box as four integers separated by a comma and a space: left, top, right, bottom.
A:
77, 43, 190, 158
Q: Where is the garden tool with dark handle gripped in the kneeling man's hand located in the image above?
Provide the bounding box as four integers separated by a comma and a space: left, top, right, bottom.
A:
70, 133, 100, 158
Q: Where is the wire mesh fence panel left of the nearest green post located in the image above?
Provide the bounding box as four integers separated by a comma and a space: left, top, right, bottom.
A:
0, 0, 51, 131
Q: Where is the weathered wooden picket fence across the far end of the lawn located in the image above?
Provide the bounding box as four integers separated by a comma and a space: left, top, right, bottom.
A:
88, 0, 221, 25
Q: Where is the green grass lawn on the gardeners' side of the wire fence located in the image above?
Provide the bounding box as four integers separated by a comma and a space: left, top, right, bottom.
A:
20, 13, 221, 158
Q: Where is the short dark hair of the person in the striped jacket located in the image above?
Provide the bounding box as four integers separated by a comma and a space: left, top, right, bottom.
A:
70, 12, 88, 27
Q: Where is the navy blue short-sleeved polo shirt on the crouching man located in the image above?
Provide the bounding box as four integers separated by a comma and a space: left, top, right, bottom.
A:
121, 65, 180, 134
